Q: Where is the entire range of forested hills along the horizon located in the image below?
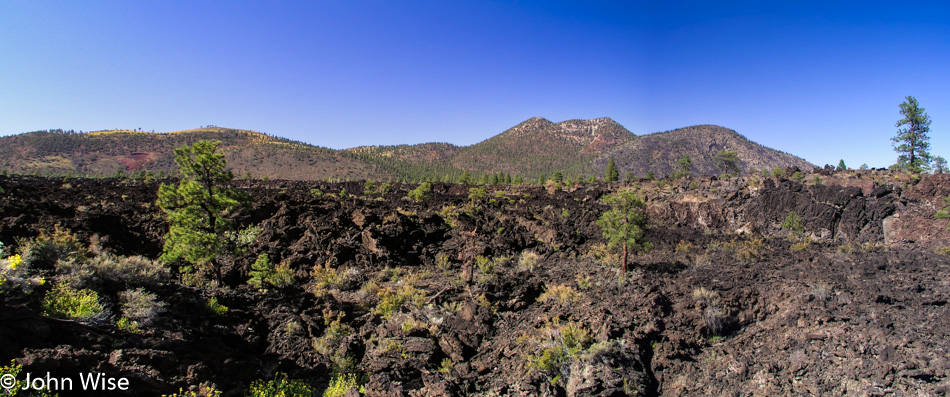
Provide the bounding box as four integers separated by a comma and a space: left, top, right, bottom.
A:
0, 121, 813, 181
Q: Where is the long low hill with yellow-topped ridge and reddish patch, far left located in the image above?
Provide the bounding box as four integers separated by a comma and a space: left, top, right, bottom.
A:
0, 127, 379, 180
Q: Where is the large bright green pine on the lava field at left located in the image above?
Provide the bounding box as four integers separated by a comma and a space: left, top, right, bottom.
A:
158, 141, 250, 282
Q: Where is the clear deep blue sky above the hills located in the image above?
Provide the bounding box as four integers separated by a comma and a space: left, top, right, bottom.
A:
0, 0, 950, 167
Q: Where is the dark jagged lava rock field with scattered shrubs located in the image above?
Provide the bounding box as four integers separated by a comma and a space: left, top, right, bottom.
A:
0, 171, 950, 396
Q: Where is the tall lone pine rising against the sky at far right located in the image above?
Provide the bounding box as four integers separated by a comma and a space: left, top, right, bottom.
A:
891, 96, 930, 173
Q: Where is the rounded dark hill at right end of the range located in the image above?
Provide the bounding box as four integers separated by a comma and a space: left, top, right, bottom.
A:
590, 125, 814, 177
